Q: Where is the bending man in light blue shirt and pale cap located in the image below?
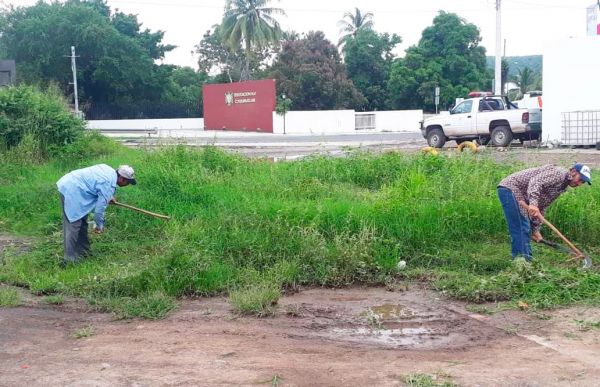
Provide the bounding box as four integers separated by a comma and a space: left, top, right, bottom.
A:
56, 164, 137, 266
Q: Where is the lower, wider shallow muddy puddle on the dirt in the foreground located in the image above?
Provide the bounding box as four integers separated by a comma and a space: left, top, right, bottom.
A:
332, 327, 434, 346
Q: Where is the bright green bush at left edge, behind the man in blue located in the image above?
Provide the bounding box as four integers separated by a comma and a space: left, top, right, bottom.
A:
0, 86, 85, 155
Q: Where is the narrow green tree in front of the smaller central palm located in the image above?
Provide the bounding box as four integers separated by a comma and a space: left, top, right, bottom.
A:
342, 29, 402, 111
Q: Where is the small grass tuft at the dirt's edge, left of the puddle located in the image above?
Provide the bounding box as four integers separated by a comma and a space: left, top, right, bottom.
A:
229, 283, 281, 317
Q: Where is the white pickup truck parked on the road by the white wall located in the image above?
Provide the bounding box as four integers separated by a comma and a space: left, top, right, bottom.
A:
421, 96, 541, 148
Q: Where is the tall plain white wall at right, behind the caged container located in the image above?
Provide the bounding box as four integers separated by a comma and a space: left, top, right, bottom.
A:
542, 36, 600, 141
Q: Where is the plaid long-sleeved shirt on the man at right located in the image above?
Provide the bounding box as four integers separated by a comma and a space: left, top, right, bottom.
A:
498, 164, 571, 231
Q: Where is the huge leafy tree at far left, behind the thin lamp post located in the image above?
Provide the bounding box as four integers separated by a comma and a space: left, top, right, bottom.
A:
0, 0, 174, 107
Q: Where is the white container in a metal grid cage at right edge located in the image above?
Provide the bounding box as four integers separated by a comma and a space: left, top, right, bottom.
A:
561, 110, 600, 145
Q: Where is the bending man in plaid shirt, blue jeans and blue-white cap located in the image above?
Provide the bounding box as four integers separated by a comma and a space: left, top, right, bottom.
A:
498, 163, 592, 261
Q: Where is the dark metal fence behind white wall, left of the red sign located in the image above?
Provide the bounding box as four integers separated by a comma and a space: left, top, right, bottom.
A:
82, 102, 202, 120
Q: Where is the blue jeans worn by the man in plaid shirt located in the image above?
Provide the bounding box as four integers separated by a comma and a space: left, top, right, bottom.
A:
498, 187, 532, 261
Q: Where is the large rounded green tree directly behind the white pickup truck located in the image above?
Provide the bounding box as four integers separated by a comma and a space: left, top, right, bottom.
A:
388, 11, 489, 111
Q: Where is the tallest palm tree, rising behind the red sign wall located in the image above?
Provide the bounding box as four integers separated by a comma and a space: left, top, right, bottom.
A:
220, 0, 285, 80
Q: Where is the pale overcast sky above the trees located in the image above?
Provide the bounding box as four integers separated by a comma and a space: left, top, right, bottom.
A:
0, 0, 596, 68
